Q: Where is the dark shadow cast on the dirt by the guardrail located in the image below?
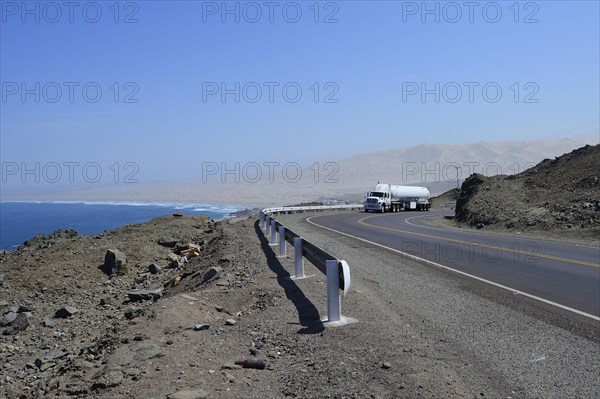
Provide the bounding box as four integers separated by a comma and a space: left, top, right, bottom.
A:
254, 221, 325, 334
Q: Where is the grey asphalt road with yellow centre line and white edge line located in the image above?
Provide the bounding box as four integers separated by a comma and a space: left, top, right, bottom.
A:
310, 212, 600, 319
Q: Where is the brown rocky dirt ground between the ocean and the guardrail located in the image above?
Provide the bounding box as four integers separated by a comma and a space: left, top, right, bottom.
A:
0, 215, 504, 399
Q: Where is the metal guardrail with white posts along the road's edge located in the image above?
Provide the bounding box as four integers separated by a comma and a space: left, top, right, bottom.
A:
260, 204, 363, 326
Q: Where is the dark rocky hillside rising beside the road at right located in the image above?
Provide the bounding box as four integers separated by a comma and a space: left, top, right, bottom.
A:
455, 145, 600, 237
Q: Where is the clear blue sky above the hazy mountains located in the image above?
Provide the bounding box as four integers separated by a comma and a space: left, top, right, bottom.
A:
0, 0, 600, 189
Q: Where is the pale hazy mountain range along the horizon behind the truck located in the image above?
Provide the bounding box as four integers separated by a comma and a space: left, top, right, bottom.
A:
0, 134, 599, 206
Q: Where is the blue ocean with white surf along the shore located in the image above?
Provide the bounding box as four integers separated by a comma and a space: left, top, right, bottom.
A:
0, 201, 243, 250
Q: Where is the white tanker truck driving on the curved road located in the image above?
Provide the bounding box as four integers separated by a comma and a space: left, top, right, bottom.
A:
364, 183, 431, 213
